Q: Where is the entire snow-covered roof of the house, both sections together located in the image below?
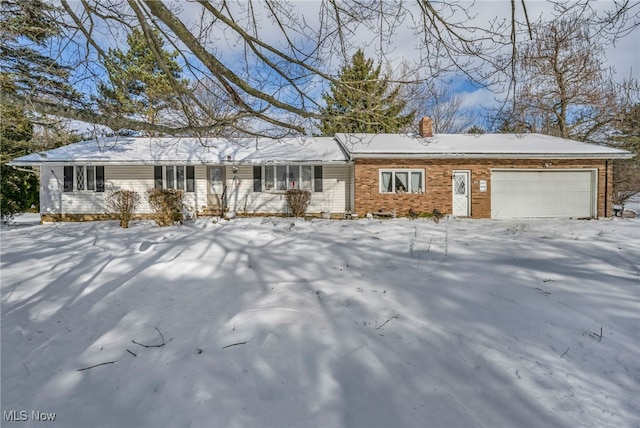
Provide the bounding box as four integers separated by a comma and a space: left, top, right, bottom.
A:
10, 134, 633, 166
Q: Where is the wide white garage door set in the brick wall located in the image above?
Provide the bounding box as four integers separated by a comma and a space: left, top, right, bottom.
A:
491, 170, 596, 218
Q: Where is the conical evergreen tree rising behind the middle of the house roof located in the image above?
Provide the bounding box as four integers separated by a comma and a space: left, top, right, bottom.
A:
320, 50, 415, 135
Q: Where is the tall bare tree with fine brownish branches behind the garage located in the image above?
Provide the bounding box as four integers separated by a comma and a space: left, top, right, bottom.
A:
490, 15, 628, 142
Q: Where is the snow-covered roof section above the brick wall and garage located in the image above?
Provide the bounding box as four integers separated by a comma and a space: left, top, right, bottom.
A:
336, 134, 633, 159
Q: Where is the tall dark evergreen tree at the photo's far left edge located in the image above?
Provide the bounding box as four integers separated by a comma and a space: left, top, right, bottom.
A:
0, 0, 78, 221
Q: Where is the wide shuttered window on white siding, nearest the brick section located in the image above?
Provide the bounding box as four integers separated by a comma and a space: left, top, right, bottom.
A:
253, 165, 322, 192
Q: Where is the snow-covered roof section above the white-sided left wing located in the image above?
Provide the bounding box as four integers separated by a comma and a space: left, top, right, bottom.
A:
11, 137, 349, 166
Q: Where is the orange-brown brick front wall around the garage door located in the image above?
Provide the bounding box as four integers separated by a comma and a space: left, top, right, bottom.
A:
354, 159, 611, 218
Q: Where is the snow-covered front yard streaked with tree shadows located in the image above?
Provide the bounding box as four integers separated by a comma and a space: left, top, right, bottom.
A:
0, 206, 640, 427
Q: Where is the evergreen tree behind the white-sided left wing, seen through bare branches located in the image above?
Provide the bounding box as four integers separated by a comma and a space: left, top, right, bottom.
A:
98, 29, 186, 124
